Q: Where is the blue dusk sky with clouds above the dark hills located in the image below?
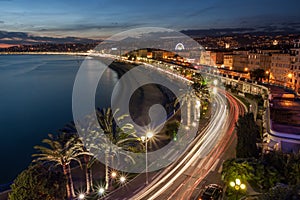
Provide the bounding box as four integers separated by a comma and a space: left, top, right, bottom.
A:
0, 0, 300, 39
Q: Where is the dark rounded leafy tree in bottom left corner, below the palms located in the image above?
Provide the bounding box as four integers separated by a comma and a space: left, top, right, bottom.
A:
9, 163, 66, 200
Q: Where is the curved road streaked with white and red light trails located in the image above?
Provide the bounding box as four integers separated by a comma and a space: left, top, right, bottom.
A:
130, 91, 245, 200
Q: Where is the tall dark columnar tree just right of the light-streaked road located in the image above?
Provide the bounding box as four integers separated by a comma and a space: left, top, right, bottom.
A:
236, 113, 260, 158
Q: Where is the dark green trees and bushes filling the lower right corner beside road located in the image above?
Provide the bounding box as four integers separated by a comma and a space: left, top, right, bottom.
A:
222, 113, 300, 200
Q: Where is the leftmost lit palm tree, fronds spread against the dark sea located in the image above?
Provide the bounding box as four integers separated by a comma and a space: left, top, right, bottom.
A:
32, 134, 85, 199
